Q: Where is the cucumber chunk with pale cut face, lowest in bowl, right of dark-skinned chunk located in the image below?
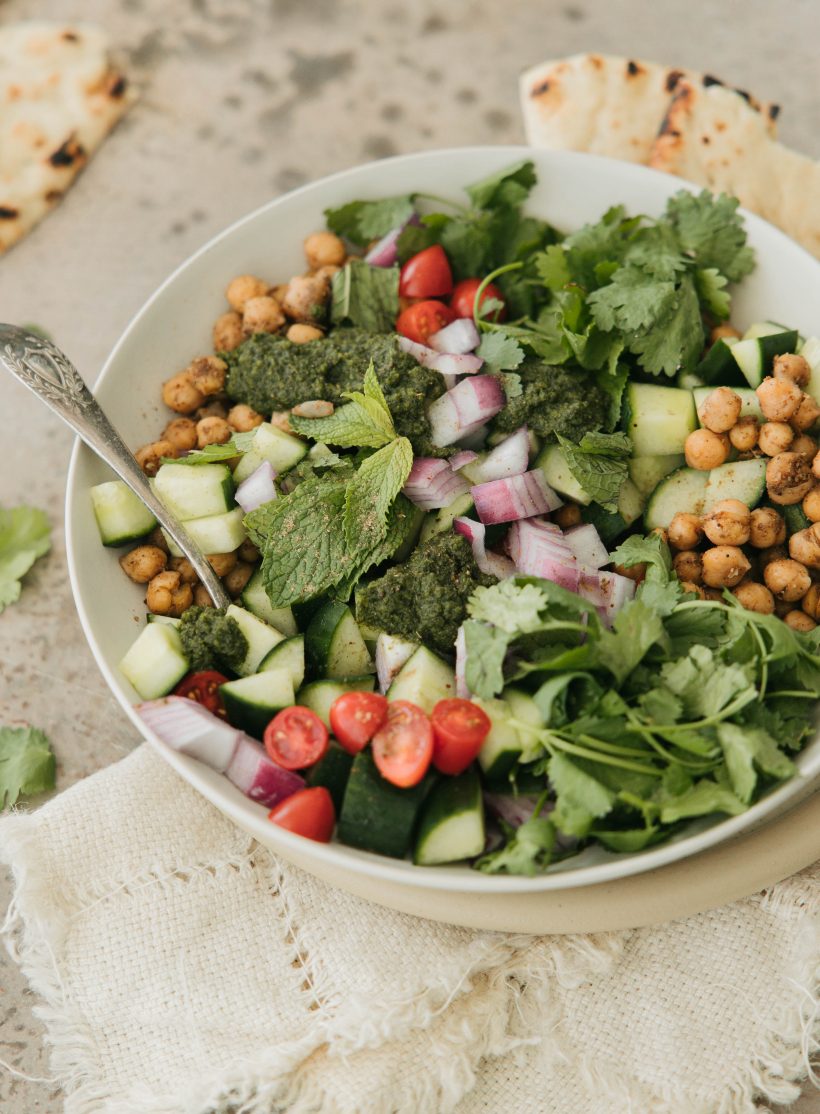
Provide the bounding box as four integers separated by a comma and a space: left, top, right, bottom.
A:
413, 770, 485, 867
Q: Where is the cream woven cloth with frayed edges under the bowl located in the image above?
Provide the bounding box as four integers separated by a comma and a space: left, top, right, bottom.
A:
0, 744, 820, 1114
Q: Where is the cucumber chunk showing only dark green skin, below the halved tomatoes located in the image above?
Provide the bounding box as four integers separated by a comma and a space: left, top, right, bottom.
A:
336, 747, 431, 859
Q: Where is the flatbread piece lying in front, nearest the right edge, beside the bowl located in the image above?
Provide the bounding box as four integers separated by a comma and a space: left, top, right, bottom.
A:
650, 81, 820, 258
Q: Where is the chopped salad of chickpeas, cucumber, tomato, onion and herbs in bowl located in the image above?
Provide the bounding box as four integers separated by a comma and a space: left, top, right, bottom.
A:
91, 162, 820, 874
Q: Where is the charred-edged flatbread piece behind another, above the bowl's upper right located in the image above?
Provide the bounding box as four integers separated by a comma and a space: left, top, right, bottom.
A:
519, 53, 778, 163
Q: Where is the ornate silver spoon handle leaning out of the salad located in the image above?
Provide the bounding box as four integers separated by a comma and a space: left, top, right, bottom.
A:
0, 324, 231, 607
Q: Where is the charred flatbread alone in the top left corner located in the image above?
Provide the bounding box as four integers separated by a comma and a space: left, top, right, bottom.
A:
0, 22, 133, 253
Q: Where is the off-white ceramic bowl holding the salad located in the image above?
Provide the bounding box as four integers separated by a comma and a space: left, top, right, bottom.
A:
66, 147, 820, 904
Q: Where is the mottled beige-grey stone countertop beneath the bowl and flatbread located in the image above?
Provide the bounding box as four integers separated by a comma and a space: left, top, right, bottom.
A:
0, 0, 820, 1114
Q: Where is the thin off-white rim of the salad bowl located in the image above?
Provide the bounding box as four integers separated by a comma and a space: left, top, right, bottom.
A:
65, 145, 820, 898
